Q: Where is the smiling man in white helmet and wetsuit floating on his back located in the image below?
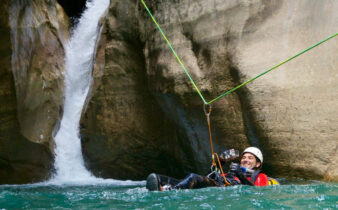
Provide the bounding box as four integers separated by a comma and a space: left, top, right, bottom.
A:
146, 147, 279, 191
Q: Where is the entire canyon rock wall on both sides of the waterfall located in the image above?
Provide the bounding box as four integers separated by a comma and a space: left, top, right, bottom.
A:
0, 0, 338, 183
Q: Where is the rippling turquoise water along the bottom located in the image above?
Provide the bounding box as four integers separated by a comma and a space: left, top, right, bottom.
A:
0, 181, 338, 209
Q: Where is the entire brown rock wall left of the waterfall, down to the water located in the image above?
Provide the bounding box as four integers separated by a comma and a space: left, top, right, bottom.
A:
0, 1, 68, 184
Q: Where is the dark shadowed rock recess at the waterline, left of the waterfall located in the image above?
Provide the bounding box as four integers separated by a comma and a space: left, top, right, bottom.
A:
0, 133, 53, 184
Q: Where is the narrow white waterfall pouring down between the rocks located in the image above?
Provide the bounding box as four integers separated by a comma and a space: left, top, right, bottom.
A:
51, 0, 109, 182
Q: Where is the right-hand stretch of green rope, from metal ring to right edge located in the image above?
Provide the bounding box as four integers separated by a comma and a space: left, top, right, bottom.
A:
207, 33, 338, 104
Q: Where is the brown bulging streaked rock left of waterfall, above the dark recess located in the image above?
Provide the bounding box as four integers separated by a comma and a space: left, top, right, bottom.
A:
9, 1, 69, 147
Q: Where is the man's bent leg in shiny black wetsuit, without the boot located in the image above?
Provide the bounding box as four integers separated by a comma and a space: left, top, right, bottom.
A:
173, 173, 219, 189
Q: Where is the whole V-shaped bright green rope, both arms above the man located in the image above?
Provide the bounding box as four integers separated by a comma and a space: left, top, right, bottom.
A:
141, 0, 338, 104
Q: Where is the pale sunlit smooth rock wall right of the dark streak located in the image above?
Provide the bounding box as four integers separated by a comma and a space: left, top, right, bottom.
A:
233, 1, 338, 180
